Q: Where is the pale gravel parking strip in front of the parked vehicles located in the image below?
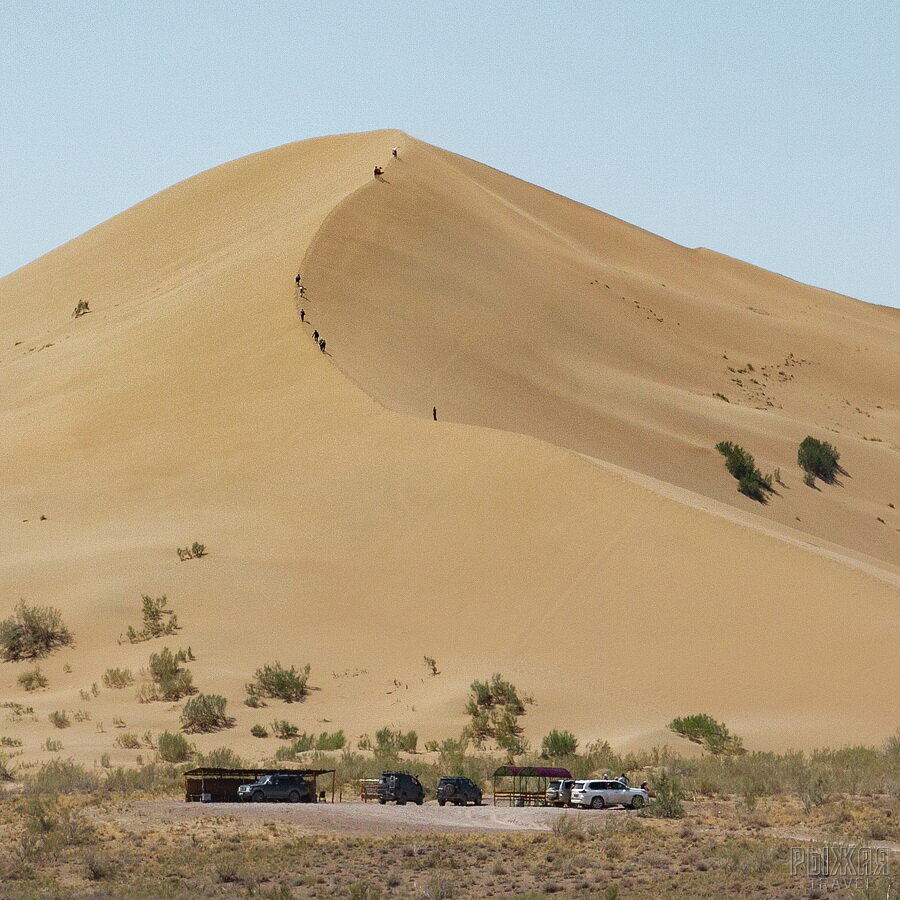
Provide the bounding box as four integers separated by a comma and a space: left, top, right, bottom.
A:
125, 801, 634, 835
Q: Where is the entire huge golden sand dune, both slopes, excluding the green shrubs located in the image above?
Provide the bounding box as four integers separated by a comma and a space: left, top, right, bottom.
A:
0, 131, 900, 761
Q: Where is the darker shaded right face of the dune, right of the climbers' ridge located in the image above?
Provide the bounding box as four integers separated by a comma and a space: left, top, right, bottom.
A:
304, 139, 900, 571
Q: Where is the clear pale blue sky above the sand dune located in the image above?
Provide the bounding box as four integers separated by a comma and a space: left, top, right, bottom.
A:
0, 0, 900, 306
